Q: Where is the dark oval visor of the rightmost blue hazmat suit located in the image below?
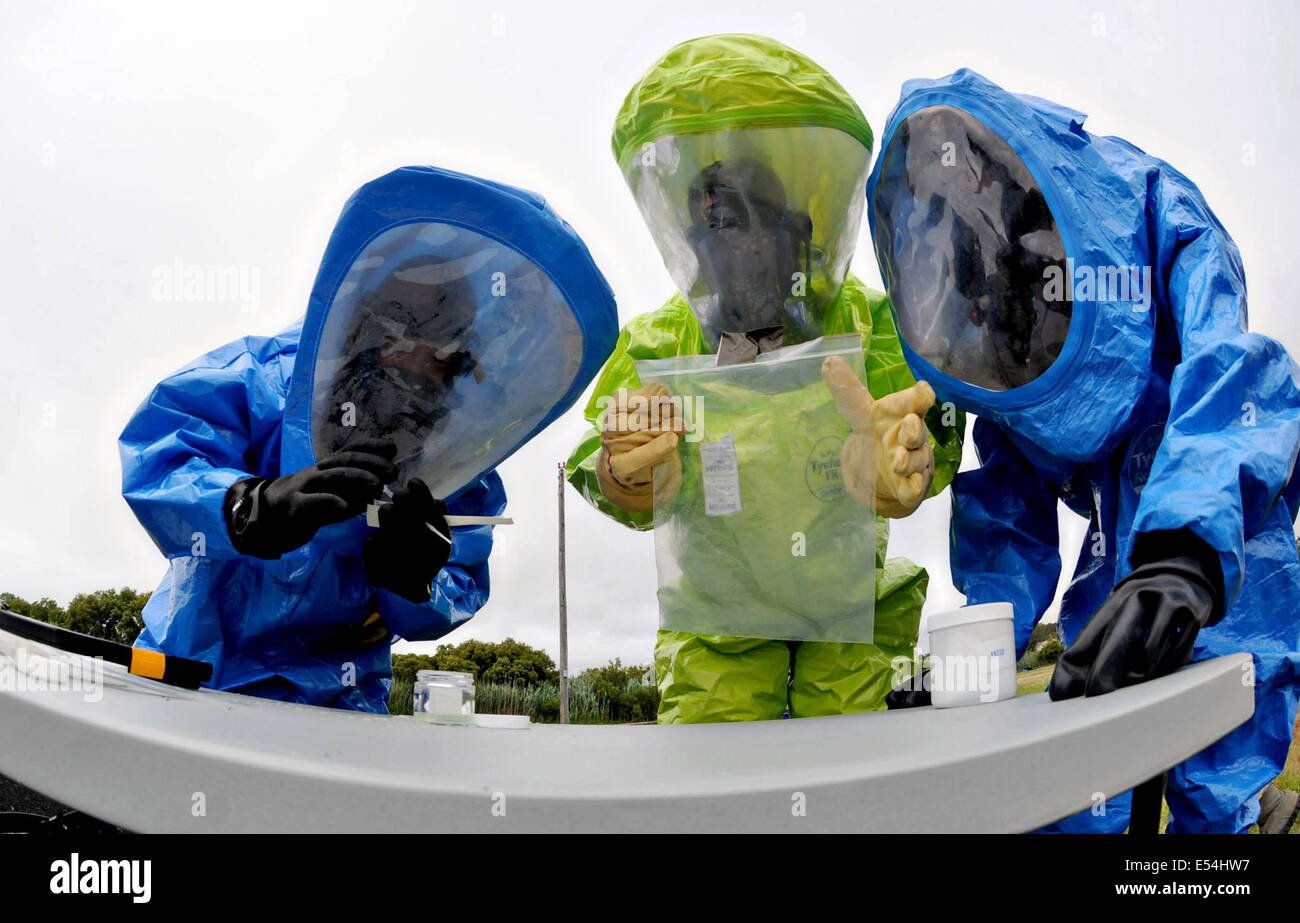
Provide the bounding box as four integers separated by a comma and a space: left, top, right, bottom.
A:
871, 105, 1073, 391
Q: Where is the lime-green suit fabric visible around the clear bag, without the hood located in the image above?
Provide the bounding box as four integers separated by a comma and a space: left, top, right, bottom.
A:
566, 276, 965, 723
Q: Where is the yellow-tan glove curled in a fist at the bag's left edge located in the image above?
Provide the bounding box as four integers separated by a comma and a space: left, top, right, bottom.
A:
595, 384, 685, 512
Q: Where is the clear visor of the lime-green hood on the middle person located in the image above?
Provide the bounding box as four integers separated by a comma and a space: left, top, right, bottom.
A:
625, 126, 870, 347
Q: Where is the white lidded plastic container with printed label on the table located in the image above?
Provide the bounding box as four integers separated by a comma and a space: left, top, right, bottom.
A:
927, 602, 1015, 709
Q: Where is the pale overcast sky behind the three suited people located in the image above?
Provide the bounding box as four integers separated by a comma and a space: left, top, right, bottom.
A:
0, 0, 1300, 670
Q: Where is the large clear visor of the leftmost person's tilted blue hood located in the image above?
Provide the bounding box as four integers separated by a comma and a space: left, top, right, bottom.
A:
312, 222, 582, 497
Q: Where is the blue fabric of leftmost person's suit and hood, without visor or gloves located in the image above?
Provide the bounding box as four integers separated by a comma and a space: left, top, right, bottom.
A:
120, 168, 618, 712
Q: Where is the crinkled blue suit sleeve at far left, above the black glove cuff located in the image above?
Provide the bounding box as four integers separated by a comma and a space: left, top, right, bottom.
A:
118, 342, 287, 559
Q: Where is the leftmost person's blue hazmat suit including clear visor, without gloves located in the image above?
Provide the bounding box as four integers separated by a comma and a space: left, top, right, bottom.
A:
120, 168, 618, 712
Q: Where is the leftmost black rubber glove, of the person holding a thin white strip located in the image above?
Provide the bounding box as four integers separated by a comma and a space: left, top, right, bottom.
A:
225, 442, 398, 559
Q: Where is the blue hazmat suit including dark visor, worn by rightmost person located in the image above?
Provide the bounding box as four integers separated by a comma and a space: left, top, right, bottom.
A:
867, 70, 1300, 833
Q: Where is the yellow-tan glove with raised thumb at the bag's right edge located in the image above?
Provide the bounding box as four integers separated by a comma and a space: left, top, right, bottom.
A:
822, 356, 935, 519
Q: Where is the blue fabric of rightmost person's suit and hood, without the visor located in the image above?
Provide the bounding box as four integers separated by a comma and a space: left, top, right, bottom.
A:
867, 70, 1300, 832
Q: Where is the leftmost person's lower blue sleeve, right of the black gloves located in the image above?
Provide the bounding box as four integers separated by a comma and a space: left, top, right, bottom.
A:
377, 471, 506, 641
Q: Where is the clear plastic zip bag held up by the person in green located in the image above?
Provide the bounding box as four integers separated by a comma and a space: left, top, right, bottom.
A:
637, 334, 876, 644
